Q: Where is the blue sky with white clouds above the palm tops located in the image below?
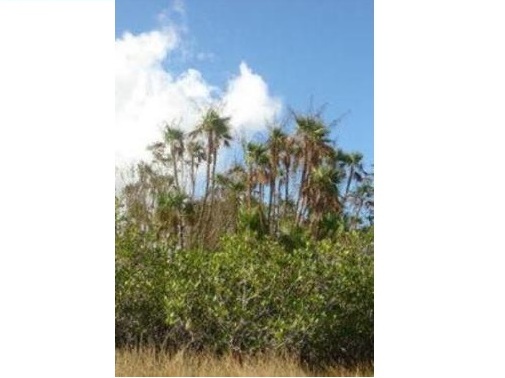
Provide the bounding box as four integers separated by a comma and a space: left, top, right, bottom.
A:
115, 0, 374, 171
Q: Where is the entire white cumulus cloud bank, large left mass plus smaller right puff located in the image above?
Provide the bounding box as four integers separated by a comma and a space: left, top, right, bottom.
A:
115, 22, 281, 173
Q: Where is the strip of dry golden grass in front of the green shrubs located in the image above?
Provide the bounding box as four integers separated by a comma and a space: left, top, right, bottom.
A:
116, 349, 373, 377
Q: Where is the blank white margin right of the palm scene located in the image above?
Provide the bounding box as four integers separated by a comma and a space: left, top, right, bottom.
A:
374, 0, 505, 377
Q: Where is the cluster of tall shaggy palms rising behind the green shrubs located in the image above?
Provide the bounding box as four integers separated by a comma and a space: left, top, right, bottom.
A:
118, 108, 374, 249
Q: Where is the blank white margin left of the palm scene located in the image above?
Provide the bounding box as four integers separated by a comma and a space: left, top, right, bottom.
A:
0, 1, 114, 377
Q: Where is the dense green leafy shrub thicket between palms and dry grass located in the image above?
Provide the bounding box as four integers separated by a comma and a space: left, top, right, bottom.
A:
116, 221, 374, 365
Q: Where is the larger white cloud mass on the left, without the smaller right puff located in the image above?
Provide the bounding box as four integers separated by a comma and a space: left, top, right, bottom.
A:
116, 29, 214, 165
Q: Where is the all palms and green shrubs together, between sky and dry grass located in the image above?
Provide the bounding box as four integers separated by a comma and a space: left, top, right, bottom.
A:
116, 109, 374, 366
